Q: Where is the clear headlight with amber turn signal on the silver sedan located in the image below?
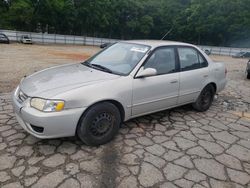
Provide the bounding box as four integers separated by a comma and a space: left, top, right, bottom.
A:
30, 98, 64, 112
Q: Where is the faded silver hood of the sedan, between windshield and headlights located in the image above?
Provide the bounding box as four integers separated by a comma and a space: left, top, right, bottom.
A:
20, 64, 120, 98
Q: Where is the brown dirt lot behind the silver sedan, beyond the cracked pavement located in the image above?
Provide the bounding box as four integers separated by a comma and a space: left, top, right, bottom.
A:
0, 44, 247, 93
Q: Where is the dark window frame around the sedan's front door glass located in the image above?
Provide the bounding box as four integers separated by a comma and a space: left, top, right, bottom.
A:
134, 45, 180, 79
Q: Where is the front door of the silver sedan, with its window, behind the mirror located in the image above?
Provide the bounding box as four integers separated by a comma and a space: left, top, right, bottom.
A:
132, 47, 179, 116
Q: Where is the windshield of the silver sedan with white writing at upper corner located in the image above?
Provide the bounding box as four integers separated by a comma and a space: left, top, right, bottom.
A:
85, 42, 150, 75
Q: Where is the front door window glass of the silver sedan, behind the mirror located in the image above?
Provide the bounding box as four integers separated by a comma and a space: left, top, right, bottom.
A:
144, 47, 176, 75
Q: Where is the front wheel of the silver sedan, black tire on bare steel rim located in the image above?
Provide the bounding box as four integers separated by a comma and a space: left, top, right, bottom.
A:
76, 102, 121, 146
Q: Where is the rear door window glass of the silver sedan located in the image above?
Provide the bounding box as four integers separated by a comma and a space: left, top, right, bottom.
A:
178, 47, 208, 71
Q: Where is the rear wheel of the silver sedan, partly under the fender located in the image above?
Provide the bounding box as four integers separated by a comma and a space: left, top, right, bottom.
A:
193, 85, 215, 112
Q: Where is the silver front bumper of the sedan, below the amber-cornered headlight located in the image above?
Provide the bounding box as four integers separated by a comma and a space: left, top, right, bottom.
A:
12, 90, 85, 139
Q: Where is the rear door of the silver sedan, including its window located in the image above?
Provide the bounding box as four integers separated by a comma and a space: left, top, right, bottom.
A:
178, 46, 209, 105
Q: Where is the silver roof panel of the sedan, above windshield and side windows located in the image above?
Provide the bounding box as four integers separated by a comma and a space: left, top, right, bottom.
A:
125, 40, 194, 48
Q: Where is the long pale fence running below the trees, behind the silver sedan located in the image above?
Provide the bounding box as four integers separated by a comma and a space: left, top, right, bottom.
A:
0, 29, 250, 56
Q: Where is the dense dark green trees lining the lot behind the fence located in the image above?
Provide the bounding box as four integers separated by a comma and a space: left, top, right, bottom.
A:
0, 0, 250, 46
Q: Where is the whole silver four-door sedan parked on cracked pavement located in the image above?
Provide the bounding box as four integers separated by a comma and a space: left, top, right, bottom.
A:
12, 41, 226, 145
